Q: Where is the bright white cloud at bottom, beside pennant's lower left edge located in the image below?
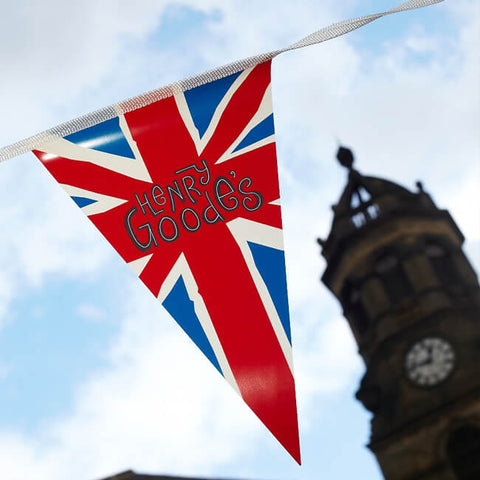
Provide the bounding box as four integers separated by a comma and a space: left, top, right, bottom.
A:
0, 281, 265, 480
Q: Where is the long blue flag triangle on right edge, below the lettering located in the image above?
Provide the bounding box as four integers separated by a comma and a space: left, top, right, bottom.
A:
248, 242, 292, 343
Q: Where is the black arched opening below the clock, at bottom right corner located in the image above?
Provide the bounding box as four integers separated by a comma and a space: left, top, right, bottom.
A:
447, 425, 480, 480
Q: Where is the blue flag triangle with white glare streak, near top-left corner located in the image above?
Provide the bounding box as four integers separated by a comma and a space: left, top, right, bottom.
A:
65, 117, 135, 158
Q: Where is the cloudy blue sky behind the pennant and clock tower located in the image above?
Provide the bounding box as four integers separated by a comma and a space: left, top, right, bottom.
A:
0, 0, 480, 480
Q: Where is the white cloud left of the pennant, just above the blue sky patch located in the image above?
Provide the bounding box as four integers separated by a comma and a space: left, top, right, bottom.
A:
0, 157, 113, 325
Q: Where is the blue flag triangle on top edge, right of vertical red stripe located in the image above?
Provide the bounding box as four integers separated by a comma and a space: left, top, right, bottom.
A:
184, 72, 241, 138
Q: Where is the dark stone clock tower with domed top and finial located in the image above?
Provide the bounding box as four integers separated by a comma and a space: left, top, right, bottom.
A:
319, 147, 480, 480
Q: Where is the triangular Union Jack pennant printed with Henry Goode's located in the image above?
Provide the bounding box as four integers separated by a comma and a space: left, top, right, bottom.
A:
34, 61, 300, 463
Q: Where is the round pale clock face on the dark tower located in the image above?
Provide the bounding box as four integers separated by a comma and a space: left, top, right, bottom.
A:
405, 337, 455, 387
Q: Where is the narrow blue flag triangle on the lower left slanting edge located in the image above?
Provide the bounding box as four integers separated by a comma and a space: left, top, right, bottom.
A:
163, 277, 223, 375
